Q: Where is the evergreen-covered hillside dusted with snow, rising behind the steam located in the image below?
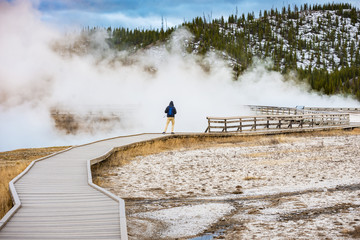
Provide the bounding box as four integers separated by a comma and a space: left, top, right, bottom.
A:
108, 4, 360, 100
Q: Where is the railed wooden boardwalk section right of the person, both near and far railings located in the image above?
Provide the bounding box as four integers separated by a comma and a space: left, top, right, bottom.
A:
205, 105, 360, 133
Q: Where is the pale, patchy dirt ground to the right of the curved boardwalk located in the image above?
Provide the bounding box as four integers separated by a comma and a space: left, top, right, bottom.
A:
102, 134, 360, 240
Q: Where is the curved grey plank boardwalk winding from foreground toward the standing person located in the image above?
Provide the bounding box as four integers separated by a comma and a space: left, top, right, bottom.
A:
0, 134, 163, 239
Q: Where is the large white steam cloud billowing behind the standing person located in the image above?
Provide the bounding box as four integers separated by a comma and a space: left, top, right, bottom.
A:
0, 1, 359, 151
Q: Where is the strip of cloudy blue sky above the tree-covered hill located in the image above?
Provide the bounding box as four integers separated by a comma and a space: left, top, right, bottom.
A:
7, 0, 360, 29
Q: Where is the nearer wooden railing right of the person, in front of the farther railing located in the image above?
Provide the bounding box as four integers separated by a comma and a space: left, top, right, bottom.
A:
205, 113, 350, 133
